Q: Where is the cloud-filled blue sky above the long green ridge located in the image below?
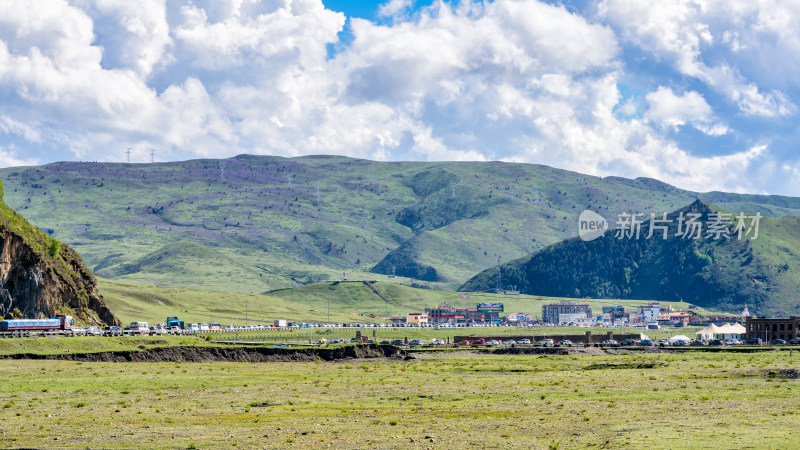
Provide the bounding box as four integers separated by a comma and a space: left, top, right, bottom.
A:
0, 0, 800, 195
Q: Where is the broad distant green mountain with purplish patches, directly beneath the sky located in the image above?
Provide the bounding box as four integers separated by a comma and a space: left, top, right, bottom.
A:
0, 155, 800, 293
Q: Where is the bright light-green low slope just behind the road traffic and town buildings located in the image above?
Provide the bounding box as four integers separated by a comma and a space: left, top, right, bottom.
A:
98, 278, 728, 324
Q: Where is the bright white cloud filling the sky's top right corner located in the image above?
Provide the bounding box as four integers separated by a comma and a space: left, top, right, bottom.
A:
598, 0, 800, 117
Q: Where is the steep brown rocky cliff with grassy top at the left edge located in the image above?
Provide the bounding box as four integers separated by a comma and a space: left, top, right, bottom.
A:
0, 184, 119, 325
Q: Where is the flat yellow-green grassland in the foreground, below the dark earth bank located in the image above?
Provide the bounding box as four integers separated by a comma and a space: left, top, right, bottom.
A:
0, 351, 800, 448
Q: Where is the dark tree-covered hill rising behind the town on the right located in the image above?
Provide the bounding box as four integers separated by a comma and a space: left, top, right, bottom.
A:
460, 201, 800, 315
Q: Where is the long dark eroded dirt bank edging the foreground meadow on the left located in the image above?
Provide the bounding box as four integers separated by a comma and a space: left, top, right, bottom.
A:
2, 344, 406, 362
